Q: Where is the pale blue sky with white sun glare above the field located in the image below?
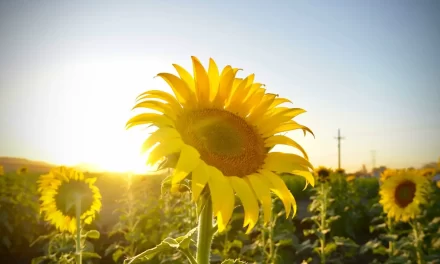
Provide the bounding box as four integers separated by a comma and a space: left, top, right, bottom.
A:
0, 0, 440, 171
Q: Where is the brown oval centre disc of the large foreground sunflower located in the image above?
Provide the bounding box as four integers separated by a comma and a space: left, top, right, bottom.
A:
177, 109, 267, 177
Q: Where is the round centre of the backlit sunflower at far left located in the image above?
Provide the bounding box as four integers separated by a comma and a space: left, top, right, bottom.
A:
55, 180, 93, 217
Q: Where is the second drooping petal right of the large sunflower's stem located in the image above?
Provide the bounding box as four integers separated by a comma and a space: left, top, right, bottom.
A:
228, 176, 259, 234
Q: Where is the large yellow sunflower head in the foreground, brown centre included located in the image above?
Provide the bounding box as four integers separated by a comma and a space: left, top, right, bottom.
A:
127, 57, 314, 232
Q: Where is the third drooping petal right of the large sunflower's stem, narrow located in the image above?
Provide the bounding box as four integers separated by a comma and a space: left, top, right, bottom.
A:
246, 174, 272, 223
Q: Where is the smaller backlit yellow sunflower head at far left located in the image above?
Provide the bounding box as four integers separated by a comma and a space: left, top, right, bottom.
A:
38, 167, 101, 233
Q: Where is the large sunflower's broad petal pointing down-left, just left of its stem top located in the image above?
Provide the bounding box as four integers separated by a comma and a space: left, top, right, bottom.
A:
172, 144, 200, 185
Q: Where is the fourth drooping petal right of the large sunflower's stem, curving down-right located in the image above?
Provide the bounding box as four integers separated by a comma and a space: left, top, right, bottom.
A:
260, 169, 296, 218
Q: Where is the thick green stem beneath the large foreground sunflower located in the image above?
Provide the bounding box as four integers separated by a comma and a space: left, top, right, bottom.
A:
197, 196, 212, 264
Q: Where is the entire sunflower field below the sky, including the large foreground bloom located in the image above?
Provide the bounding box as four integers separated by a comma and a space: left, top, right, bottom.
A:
0, 57, 440, 264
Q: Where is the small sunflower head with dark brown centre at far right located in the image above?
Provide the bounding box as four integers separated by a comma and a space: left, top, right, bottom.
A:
380, 170, 428, 222
